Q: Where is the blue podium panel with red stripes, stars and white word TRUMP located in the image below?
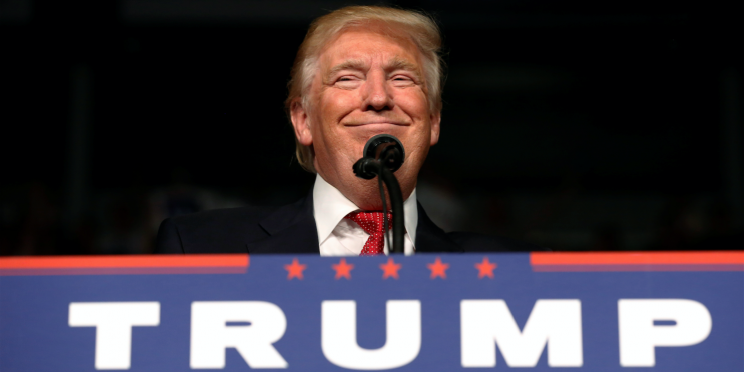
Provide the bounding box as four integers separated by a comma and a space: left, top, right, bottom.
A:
0, 252, 744, 372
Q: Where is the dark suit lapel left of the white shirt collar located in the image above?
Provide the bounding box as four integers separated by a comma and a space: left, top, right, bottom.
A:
246, 191, 320, 254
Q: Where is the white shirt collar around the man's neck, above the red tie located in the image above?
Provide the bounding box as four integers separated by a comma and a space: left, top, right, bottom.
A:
313, 175, 418, 247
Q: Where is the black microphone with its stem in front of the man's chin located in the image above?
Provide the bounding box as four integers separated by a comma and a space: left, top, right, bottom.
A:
353, 134, 406, 253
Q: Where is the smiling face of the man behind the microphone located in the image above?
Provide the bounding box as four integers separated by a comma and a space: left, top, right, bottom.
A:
292, 29, 439, 209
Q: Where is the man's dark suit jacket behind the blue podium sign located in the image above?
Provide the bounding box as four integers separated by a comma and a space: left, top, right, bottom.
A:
155, 193, 542, 254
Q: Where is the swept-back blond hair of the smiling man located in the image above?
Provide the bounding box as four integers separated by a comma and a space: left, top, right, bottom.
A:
284, 6, 443, 173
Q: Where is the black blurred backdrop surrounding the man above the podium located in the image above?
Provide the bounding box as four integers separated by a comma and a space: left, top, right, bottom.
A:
0, 0, 744, 255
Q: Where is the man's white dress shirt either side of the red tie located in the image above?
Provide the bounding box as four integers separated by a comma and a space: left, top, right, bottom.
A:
313, 175, 418, 256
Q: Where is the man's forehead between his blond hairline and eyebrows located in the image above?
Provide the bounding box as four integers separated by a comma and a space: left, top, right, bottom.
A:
319, 28, 421, 69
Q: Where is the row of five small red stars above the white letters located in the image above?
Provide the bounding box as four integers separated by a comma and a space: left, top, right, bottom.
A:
284, 257, 496, 280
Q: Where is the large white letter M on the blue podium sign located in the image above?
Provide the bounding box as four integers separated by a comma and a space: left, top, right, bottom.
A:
460, 299, 584, 367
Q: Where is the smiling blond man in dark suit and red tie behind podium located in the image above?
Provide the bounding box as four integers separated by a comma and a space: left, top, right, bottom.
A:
157, 6, 529, 256
